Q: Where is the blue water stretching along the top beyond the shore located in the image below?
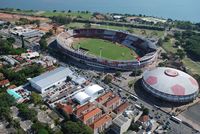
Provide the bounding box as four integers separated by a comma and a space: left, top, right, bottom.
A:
0, 0, 200, 22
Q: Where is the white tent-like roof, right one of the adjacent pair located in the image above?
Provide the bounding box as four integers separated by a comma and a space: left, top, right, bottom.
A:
85, 84, 103, 97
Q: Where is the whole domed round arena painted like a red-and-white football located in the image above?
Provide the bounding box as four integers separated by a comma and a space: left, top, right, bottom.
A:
142, 67, 199, 102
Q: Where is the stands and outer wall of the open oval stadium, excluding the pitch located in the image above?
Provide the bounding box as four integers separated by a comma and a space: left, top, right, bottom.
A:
57, 29, 157, 71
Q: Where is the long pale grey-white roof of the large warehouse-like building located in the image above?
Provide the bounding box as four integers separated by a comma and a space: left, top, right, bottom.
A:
29, 67, 73, 89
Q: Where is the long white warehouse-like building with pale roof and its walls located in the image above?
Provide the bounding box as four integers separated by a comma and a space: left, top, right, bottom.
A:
29, 67, 73, 93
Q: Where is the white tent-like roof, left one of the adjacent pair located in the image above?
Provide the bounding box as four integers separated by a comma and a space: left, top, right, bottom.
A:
74, 92, 90, 104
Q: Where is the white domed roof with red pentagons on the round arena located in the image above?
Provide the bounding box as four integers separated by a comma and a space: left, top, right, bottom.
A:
143, 67, 199, 96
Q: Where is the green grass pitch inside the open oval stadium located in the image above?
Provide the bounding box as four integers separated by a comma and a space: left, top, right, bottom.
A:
73, 38, 137, 60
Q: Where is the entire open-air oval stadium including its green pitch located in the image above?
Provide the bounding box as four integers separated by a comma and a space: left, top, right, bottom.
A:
56, 29, 157, 71
